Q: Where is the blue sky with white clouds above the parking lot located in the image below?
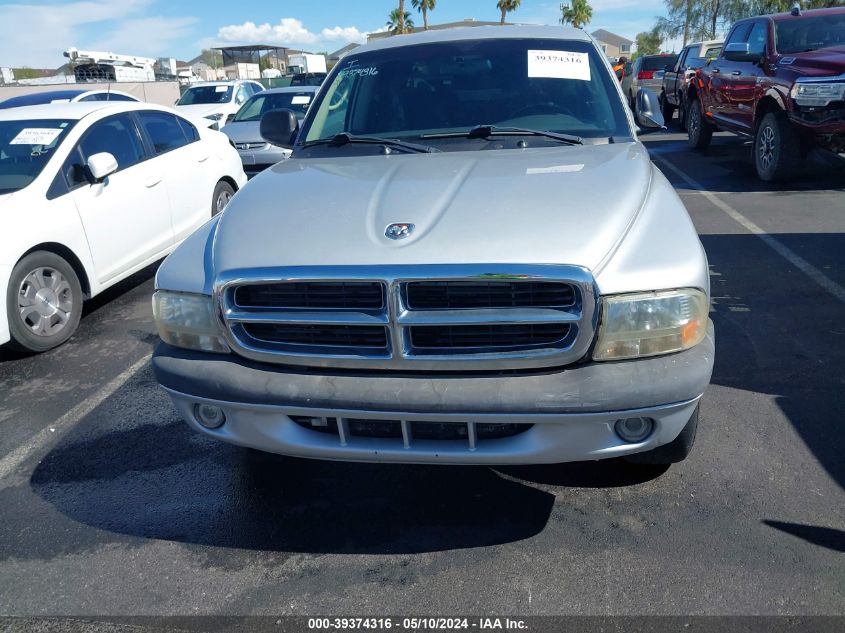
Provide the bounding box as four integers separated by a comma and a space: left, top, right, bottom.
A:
0, 0, 664, 68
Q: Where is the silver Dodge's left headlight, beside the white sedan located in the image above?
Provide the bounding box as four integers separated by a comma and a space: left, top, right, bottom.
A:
153, 290, 230, 354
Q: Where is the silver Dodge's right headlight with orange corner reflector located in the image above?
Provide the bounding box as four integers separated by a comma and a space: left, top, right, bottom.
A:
593, 288, 710, 360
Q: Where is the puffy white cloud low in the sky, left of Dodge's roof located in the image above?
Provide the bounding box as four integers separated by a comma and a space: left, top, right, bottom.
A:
214, 18, 376, 50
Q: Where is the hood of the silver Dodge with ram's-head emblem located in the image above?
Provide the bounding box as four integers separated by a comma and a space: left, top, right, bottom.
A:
214, 142, 652, 274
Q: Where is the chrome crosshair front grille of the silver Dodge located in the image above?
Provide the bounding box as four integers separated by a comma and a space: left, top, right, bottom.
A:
215, 266, 596, 371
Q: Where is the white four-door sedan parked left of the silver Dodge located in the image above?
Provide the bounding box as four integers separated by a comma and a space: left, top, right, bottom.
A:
0, 101, 246, 352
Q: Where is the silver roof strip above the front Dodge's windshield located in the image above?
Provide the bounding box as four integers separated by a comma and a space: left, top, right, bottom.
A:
356, 22, 590, 53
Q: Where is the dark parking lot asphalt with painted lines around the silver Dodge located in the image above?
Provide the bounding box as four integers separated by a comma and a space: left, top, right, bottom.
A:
0, 128, 845, 615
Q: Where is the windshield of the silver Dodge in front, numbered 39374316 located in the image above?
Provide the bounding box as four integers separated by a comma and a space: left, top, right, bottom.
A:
299, 39, 631, 150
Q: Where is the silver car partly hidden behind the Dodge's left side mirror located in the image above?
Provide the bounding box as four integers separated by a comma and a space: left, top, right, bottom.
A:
222, 86, 317, 176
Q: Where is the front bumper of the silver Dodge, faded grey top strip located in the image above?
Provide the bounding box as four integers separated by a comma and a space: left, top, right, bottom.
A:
153, 324, 715, 464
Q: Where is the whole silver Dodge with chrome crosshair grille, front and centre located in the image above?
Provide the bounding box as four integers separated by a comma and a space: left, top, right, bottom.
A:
153, 27, 714, 464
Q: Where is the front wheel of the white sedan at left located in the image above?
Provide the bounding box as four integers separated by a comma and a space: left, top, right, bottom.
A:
6, 251, 83, 352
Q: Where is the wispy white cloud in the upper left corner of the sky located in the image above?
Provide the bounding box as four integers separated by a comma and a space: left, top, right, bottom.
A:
0, 0, 194, 68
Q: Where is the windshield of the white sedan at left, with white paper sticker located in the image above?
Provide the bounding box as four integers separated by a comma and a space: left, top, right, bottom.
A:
0, 119, 75, 194
